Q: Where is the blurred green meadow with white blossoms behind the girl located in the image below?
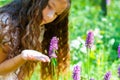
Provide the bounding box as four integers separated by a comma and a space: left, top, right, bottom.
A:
0, 0, 120, 80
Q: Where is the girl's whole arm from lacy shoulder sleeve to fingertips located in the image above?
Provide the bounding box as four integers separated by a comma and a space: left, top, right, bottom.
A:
0, 13, 50, 75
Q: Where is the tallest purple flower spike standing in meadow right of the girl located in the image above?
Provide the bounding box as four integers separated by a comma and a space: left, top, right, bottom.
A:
85, 31, 94, 48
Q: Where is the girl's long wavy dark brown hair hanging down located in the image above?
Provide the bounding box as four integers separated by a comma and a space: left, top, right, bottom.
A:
0, 0, 71, 80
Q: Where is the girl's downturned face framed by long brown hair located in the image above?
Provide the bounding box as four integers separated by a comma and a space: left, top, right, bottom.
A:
41, 0, 68, 25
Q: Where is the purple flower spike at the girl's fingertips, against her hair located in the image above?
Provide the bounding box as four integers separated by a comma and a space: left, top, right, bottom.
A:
49, 37, 58, 58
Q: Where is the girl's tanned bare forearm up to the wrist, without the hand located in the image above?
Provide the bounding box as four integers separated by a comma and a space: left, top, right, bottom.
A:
0, 54, 26, 75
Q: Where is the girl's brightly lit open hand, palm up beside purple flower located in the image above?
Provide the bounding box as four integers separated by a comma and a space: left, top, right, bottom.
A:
21, 50, 50, 62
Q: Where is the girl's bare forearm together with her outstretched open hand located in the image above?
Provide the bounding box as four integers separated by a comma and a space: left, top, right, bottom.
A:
0, 50, 50, 75
